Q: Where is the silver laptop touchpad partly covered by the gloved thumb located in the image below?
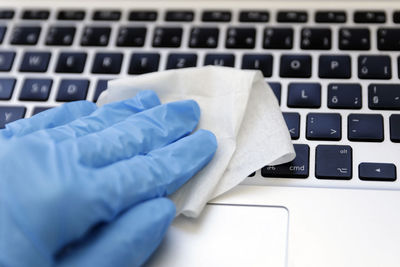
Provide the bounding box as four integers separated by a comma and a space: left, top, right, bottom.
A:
146, 204, 289, 267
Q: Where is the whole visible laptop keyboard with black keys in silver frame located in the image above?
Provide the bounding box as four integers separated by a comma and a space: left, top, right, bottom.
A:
0, 8, 400, 189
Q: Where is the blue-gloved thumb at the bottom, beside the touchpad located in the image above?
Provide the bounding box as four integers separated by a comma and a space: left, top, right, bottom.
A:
56, 198, 175, 267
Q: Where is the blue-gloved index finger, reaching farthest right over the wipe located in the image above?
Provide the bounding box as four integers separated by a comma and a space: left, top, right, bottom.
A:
84, 130, 217, 226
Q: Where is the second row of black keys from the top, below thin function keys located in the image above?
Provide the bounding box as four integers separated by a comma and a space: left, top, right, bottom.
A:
6, 26, 400, 51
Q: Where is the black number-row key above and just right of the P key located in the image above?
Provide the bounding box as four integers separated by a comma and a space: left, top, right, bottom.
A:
339, 28, 370, 50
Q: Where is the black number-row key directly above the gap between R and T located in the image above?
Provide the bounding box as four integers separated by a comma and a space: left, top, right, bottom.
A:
117, 27, 147, 47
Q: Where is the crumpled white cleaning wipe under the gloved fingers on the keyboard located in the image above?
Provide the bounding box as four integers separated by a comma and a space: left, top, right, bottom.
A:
97, 66, 295, 217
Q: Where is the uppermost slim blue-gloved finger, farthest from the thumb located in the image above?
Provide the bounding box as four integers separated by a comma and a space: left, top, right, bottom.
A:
31, 90, 160, 142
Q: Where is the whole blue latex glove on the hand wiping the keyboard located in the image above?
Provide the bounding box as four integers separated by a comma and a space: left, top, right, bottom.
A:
0, 91, 216, 267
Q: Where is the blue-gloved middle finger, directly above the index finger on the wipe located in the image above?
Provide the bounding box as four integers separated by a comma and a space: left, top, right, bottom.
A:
77, 100, 200, 167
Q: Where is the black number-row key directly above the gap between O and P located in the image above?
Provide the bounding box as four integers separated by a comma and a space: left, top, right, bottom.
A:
301, 28, 332, 50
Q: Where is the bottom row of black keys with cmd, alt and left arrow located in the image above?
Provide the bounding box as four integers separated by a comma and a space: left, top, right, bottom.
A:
260, 144, 397, 181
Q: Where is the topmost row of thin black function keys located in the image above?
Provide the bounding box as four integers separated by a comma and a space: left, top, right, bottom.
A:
0, 9, 400, 23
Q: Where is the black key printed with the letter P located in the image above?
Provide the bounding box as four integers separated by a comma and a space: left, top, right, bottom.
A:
318, 55, 351, 79
